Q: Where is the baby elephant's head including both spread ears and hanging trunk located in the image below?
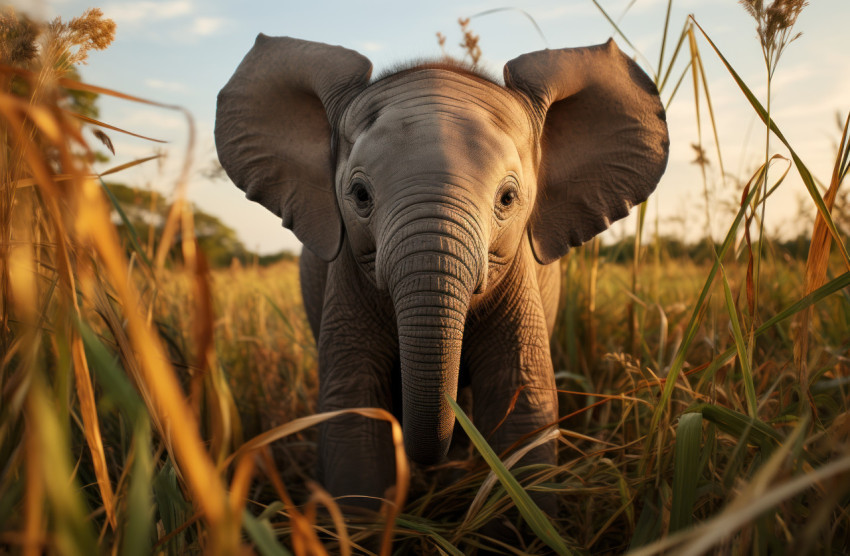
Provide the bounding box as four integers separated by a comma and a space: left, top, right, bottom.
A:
215, 35, 668, 463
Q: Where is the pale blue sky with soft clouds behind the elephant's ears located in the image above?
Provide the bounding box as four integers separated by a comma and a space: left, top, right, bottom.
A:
12, 0, 850, 252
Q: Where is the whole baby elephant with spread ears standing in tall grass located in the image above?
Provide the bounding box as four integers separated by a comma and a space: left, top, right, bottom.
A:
215, 35, 668, 505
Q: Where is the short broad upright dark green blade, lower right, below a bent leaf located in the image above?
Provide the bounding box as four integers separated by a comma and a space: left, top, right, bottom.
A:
670, 413, 702, 533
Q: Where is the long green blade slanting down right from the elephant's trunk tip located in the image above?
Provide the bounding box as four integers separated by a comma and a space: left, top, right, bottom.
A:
446, 396, 571, 554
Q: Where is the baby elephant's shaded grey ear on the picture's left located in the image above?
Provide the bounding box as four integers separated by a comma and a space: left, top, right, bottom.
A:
215, 34, 372, 261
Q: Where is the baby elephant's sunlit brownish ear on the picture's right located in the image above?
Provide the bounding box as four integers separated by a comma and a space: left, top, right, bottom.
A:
505, 40, 670, 264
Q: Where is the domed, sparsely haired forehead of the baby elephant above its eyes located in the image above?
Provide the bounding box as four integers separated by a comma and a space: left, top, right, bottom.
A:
340, 70, 533, 183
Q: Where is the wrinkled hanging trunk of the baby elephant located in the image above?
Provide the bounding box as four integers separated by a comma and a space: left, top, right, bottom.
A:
379, 215, 487, 464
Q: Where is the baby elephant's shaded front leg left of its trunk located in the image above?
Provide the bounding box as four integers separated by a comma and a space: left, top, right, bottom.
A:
319, 255, 398, 510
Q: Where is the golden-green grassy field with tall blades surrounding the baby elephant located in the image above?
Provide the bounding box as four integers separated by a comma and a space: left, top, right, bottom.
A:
0, 2, 850, 554
